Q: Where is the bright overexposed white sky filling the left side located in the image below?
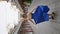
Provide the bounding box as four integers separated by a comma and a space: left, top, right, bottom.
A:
0, 1, 18, 34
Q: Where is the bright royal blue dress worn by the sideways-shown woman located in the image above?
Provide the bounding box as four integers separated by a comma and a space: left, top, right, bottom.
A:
32, 6, 49, 24
